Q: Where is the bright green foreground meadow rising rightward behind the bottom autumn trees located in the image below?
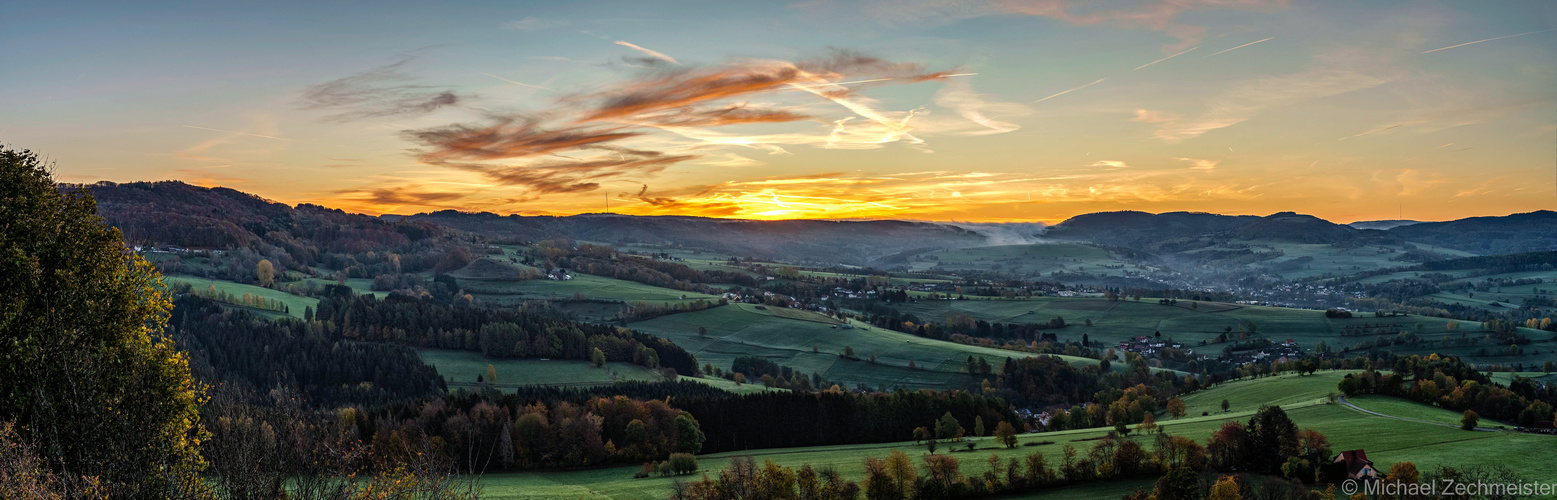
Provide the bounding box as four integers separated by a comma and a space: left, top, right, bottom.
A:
483, 374, 1557, 498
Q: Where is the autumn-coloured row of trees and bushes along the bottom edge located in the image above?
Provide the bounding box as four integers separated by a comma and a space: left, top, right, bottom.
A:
670, 407, 1345, 500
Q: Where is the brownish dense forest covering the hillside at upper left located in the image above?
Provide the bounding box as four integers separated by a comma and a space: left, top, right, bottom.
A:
79, 181, 480, 283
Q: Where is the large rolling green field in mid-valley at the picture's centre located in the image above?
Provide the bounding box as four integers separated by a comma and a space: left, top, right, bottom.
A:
629, 304, 1158, 388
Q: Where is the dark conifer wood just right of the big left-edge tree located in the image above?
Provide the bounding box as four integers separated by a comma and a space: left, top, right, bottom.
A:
170, 296, 445, 407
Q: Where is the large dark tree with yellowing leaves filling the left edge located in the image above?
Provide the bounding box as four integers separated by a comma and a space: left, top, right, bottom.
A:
0, 150, 207, 497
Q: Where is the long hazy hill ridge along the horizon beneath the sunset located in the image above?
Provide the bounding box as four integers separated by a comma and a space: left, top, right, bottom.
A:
62, 181, 1557, 257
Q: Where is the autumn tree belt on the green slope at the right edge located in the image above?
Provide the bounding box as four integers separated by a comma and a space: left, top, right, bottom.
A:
1337, 354, 1557, 427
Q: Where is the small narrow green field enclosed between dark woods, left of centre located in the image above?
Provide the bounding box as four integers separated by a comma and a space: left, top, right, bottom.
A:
417, 349, 662, 393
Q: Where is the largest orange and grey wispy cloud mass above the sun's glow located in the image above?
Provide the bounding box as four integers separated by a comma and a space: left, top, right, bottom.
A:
376, 51, 984, 195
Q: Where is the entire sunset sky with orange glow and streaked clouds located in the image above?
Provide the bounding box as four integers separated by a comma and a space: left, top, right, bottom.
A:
0, 0, 1557, 223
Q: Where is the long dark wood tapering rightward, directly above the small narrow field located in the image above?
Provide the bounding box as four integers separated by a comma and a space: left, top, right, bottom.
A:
305, 285, 698, 375
